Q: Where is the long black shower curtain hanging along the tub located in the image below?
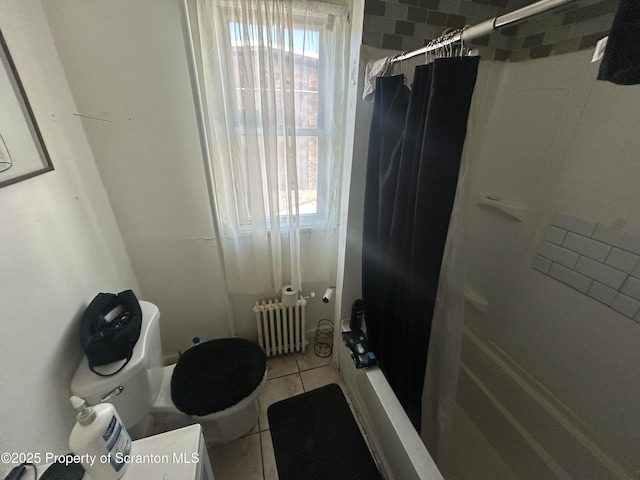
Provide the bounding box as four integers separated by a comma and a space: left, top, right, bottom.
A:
362, 57, 479, 431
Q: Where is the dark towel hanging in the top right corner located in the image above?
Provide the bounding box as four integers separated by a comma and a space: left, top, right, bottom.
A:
598, 0, 640, 85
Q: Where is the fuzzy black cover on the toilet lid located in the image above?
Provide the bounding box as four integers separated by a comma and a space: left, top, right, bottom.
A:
171, 338, 267, 416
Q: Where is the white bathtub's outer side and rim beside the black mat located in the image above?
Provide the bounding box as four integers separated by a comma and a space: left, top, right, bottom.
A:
337, 326, 444, 480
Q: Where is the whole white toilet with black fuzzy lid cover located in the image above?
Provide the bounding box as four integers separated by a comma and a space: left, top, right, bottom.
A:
71, 301, 267, 444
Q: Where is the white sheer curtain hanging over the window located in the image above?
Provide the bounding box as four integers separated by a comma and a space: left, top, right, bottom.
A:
197, 0, 348, 294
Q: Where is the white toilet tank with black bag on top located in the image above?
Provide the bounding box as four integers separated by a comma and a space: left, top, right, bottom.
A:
71, 301, 162, 428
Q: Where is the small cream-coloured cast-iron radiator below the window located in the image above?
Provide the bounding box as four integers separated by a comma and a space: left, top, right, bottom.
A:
253, 297, 308, 357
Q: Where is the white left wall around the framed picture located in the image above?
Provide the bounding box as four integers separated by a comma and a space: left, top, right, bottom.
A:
0, 0, 139, 476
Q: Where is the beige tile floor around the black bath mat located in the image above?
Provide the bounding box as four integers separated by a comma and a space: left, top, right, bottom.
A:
209, 346, 351, 480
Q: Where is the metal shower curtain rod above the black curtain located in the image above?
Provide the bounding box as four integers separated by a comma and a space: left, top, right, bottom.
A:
391, 0, 576, 62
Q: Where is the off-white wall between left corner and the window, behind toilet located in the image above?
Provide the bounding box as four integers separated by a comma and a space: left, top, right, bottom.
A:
38, 0, 232, 354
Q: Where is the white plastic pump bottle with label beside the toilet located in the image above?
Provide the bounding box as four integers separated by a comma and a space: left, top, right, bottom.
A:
69, 395, 131, 480
